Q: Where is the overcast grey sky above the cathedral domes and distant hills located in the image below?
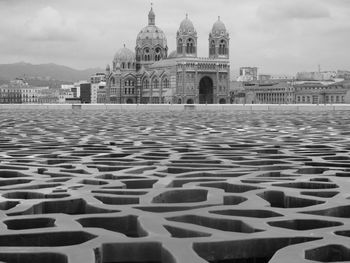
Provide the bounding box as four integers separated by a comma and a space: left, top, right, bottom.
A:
0, 0, 350, 74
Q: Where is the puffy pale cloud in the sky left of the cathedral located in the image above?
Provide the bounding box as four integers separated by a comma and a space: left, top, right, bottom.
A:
26, 6, 77, 41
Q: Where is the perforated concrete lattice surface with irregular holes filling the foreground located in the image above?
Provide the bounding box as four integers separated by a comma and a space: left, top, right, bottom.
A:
0, 109, 350, 263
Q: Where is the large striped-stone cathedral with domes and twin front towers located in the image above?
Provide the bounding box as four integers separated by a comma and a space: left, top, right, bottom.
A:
106, 8, 230, 104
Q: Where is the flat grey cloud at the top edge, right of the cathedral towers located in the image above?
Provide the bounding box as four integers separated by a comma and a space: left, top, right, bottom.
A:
257, 0, 331, 20
